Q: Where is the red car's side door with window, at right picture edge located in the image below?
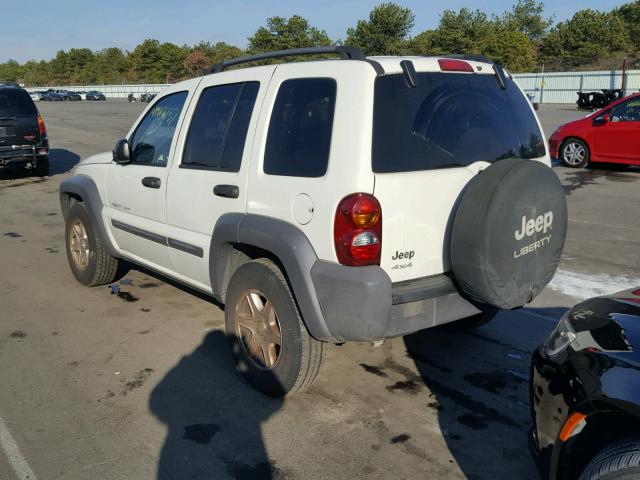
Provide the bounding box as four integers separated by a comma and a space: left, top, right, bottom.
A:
594, 96, 640, 162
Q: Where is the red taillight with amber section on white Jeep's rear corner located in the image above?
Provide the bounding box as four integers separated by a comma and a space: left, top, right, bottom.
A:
333, 193, 382, 267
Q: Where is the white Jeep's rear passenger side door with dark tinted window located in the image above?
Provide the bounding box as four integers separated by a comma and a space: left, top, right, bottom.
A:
167, 67, 275, 291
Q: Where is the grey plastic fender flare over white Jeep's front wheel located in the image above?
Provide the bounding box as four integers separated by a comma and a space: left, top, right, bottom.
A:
59, 175, 121, 258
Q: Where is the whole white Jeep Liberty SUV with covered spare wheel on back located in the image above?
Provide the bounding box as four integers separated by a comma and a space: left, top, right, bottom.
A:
60, 46, 567, 395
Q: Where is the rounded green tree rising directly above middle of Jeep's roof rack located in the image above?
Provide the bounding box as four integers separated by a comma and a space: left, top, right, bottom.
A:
248, 15, 331, 53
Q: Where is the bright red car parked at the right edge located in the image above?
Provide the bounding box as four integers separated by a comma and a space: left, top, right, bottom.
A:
549, 93, 640, 168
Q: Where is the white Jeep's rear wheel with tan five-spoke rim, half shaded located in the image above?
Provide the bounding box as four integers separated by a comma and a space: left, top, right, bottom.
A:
225, 258, 324, 397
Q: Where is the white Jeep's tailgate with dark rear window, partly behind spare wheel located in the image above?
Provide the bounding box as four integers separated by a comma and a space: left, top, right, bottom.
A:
372, 69, 546, 282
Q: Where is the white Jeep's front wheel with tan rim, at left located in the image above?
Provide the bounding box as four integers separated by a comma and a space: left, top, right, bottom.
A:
65, 202, 121, 287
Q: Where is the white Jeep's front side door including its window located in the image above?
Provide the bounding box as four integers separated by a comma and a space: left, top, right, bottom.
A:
107, 86, 195, 272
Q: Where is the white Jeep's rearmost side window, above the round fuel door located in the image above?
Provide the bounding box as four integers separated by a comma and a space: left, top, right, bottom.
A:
264, 78, 337, 177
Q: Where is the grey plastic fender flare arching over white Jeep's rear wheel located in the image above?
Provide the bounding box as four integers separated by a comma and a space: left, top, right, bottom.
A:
209, 213, 334, 341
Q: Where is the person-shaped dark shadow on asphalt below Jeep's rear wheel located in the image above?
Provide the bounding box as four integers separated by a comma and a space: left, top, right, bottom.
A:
149, 331, 283, 480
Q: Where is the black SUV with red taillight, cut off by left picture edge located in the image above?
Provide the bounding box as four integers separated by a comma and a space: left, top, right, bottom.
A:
0, 84, 49, 176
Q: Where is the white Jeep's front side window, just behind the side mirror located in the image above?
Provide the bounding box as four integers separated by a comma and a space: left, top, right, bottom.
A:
129, 92, 187, 167
